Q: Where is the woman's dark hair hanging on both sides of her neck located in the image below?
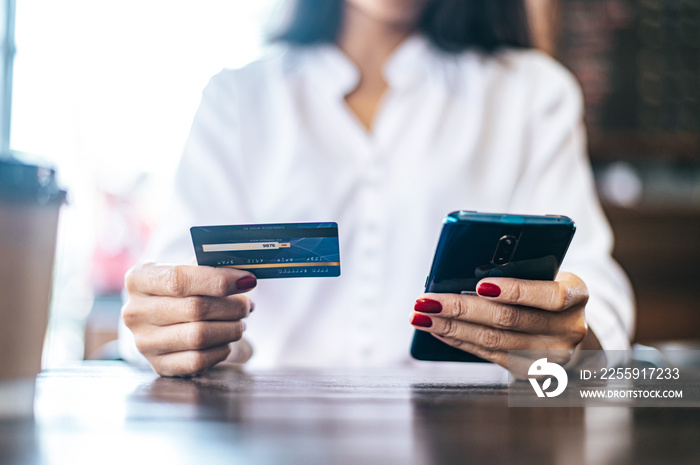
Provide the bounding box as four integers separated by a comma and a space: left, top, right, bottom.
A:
275, 0, 532, 52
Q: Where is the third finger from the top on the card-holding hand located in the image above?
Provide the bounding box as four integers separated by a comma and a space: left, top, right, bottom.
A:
136, 321, 245, 356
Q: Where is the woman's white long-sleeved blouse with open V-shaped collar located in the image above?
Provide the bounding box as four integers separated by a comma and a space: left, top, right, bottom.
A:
121, 36, 634, 367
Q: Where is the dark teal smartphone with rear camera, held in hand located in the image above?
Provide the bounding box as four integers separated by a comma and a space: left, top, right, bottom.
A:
411, 211, 576, 362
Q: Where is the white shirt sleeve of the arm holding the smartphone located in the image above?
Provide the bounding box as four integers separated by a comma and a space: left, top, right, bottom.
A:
511, 58, 634, 355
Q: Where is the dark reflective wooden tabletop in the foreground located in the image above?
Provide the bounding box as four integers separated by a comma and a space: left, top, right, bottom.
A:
0, 362, 700, 465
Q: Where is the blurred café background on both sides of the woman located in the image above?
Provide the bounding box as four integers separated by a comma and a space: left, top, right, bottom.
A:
0, 0, 700, 367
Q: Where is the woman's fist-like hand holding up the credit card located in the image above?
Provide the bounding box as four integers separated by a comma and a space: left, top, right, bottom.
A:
122, 263, 257, 376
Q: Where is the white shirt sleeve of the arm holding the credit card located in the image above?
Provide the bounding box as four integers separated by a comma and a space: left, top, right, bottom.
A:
119, 71, 252, 365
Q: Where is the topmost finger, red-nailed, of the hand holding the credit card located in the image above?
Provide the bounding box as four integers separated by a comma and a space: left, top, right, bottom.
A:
125, 263, 257, 297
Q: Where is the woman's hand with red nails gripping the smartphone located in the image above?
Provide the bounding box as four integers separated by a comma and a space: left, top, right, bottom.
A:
411, 273, 593, 371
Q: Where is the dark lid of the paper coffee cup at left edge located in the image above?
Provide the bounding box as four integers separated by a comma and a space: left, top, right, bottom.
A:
0, 157, 66, 205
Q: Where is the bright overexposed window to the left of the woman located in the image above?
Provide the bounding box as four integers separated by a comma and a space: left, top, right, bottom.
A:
11, 0, 275, 366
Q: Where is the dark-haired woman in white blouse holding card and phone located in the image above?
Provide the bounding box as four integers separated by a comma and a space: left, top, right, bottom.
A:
122, 0, 633, 376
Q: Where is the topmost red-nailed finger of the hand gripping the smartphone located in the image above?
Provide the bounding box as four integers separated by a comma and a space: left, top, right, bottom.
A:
476, 273, 588, 312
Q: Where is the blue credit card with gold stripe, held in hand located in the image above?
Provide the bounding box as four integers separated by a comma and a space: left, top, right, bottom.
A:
190, 223, 340, 279
